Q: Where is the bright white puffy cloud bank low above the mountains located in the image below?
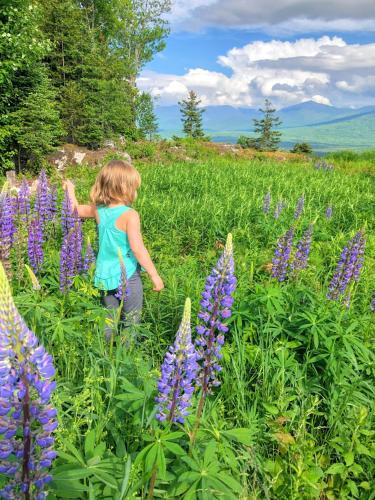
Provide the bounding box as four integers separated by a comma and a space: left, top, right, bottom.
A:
138, 36, 375, 107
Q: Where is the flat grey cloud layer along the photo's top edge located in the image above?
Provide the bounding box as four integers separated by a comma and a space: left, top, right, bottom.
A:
171, 0, 375, 34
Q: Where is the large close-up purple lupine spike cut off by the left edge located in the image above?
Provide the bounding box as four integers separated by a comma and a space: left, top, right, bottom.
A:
0, 264, 57, 500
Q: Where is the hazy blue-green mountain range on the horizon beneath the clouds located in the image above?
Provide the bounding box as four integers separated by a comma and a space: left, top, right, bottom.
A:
156, 101, 375, 152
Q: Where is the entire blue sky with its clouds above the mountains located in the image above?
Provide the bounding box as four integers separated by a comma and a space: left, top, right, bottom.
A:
138, 0, 375, 107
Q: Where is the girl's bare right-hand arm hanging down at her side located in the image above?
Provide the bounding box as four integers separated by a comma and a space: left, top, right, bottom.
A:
123, 210, 164, 292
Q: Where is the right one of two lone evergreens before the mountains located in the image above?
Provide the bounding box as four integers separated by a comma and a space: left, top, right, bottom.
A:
253, 99, 282, 151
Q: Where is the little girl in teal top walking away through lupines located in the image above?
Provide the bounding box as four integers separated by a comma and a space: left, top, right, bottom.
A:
64, 160, 164, 336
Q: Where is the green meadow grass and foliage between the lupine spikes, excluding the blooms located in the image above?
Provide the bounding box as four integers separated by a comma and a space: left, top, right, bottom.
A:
1, 143, 375, 500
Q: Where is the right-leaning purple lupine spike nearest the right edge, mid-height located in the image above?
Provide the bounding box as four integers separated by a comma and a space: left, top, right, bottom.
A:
327, 229, 366, 306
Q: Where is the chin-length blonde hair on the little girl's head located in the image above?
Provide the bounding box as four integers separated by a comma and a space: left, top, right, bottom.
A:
90, 160, 141, 205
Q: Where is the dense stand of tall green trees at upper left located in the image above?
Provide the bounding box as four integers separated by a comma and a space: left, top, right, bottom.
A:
0, 0, 170, 171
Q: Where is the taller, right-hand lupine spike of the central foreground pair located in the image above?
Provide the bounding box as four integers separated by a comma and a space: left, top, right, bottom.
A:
195, 234, 237, 394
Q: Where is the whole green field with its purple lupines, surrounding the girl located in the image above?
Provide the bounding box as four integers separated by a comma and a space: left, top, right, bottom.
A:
0, 150, 375, 500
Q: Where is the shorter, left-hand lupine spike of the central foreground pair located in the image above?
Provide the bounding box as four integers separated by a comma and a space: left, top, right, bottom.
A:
156, 299, 198, 424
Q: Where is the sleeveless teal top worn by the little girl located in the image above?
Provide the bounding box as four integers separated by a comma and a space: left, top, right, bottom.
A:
94, 205, 138, 290
